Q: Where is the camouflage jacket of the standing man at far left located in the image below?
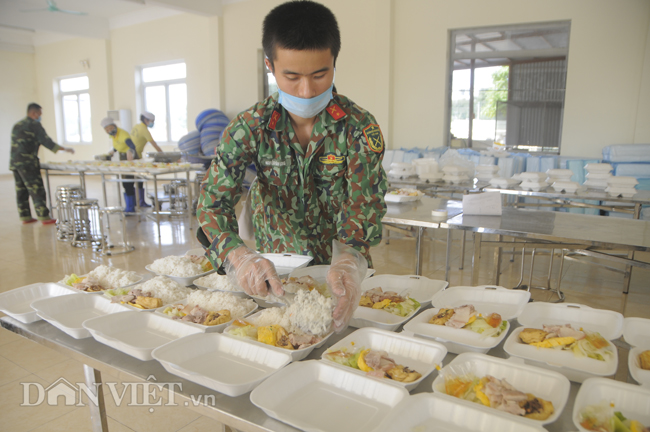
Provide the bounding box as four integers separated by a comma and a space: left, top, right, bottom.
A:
9, 117, 61, 171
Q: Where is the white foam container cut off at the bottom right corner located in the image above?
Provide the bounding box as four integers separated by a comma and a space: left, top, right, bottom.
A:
573, 378, 650, 432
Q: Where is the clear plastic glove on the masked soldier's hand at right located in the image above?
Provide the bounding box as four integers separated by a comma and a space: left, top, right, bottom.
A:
327, 240, 368, 333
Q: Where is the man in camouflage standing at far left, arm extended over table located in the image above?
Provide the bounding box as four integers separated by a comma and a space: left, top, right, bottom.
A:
9, 103, 74, 225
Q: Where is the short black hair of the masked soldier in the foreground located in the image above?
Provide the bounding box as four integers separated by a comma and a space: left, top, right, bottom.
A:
262, 0, 341, 65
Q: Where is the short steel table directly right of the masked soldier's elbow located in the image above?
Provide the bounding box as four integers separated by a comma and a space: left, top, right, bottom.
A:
382, 197, 463, 275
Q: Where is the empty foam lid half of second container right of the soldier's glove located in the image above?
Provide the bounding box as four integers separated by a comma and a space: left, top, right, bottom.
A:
431, 285, 530, 320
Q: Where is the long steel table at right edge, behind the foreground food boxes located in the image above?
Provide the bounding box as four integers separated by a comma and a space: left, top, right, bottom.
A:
441, 208, 650, 293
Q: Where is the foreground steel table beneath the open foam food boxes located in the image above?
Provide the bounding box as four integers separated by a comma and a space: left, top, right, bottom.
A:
0, 308, 634, 432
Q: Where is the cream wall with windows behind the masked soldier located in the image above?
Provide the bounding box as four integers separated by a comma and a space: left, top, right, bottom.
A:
5, 0, 650, 159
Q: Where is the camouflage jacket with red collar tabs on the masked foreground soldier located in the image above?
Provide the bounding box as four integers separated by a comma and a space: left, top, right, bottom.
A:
197, 93, 387, 266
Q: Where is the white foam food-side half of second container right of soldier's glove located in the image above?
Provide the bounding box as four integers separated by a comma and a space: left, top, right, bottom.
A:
404, 308, 510, 354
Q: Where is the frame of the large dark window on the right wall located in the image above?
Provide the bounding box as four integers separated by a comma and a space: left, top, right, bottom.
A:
443, 20, 571, 156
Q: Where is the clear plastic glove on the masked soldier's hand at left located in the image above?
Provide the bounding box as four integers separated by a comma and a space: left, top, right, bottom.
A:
224, 245, 284, 297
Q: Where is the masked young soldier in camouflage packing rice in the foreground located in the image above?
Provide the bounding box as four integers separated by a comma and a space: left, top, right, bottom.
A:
197, 1, 387, 331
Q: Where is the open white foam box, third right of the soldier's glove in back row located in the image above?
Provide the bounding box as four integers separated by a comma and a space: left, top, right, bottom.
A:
503, 302, 623, 382
